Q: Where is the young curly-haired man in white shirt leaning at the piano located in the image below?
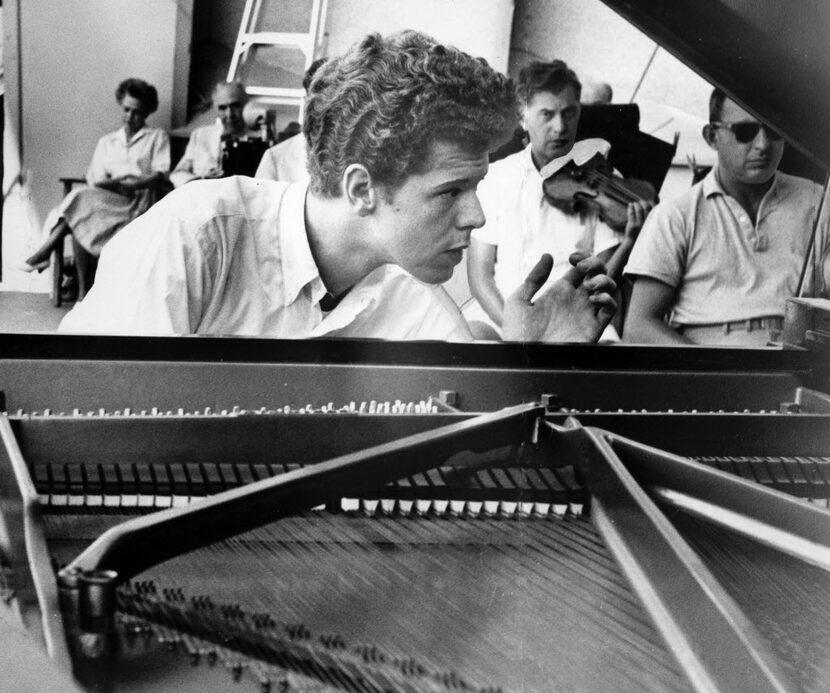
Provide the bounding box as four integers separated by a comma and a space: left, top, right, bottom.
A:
61, 32, 615, 341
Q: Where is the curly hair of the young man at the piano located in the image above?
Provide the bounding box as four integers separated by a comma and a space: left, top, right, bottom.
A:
303, 31, 517, 197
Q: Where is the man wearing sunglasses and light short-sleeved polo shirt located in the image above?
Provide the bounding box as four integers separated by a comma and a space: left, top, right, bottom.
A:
624, 89, 827, 346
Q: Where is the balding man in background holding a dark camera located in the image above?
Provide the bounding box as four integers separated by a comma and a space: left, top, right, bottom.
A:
170, 82, 267, 188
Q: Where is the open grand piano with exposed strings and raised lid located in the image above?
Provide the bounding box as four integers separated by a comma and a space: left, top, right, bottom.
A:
0, 0, 830, 693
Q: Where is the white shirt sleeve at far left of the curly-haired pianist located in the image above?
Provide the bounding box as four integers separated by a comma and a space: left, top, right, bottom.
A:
58, 194, 215, 335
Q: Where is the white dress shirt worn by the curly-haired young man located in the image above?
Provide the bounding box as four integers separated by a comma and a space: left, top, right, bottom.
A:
59, 176, 472, 341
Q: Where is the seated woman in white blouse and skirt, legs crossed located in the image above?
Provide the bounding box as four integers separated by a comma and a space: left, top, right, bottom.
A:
20, 78, 170, 300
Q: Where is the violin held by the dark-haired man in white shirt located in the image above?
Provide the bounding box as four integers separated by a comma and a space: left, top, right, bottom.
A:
542, 154, 657, 228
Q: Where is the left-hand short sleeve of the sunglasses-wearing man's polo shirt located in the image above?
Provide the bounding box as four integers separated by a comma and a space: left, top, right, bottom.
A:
623, 196, 690, 287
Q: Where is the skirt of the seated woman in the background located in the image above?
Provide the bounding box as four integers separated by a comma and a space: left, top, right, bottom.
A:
59, 186, 159, 256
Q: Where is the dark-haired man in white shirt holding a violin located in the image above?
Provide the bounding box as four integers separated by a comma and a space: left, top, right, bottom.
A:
464, 60, 651, 337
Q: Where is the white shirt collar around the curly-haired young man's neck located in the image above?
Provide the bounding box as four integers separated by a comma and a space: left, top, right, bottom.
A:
277, 184, 326, 306
